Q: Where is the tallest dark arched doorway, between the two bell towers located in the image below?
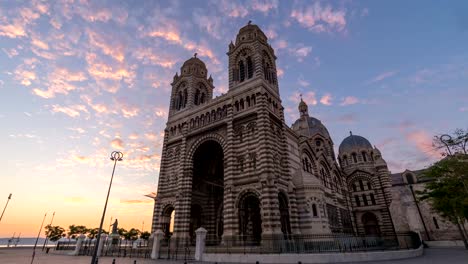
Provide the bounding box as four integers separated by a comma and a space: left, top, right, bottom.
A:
190, 140, 224, 243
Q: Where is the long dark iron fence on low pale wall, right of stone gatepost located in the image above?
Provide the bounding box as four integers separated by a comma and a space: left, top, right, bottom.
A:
205, 233, 421, 254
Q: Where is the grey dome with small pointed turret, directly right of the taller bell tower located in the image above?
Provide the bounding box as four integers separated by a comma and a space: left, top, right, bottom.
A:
292, 98, 330, 138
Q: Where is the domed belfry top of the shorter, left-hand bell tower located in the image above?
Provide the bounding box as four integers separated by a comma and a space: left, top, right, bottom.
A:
169, 53, 214, 117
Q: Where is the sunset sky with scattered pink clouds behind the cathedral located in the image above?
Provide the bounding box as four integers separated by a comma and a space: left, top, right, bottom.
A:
0, 0, 468, 237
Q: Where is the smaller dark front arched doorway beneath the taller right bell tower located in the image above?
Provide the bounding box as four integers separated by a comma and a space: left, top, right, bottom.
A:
239, 193, 262, 243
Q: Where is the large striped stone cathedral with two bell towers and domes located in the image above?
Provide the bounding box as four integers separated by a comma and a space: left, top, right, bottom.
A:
152, 22, 462, 242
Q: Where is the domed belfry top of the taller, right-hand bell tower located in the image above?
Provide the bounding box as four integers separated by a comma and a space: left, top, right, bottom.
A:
227, 21, 279, 96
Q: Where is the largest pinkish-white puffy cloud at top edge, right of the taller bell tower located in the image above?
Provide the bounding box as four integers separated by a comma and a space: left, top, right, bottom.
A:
290, 1, 346, 33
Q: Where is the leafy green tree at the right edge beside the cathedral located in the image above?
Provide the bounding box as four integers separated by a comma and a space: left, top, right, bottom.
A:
417, 129, 468, 249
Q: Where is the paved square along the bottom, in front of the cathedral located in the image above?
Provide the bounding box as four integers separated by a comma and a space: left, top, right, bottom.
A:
0, 248, 468, 264
